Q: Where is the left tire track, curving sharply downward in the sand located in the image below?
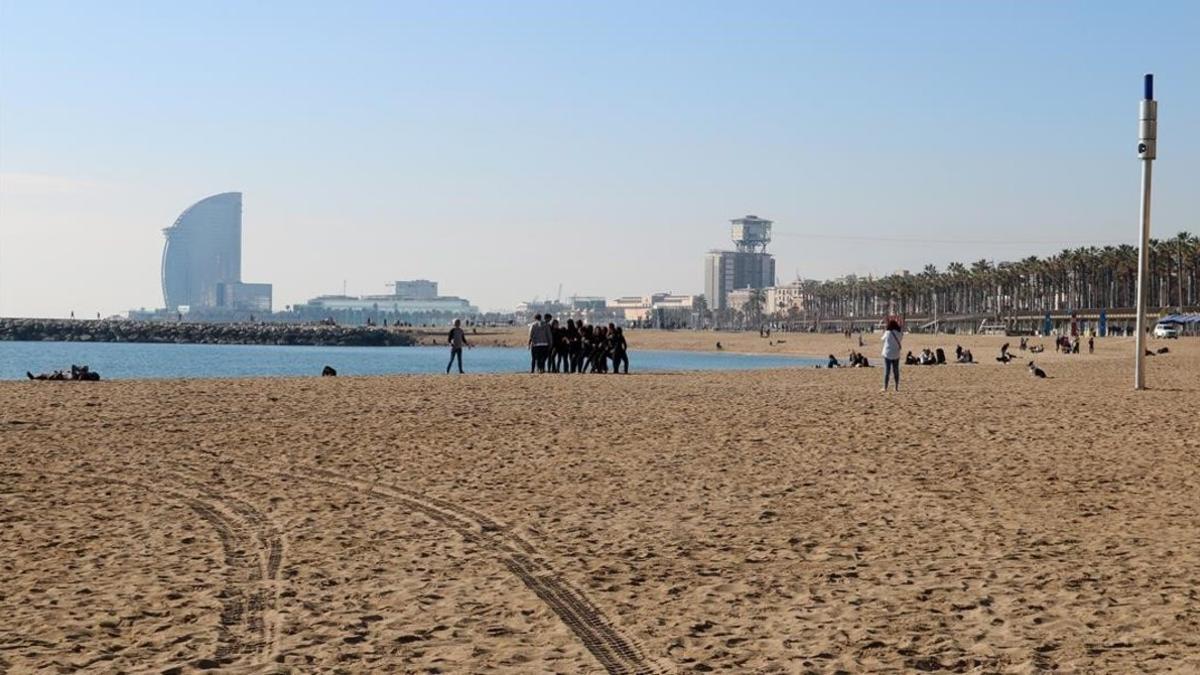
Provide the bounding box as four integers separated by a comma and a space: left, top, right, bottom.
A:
15, 467, 283, 665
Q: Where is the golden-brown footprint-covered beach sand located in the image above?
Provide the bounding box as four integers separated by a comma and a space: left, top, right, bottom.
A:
0, 331, 1200, 673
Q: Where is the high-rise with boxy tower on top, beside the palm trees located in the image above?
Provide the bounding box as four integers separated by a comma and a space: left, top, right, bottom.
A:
704, 215, 775, 310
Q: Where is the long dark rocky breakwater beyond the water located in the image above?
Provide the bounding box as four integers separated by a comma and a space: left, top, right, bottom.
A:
0, 318, 416, 347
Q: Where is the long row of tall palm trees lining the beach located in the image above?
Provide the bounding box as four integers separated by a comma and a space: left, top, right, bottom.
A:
730, 232, 1200, 323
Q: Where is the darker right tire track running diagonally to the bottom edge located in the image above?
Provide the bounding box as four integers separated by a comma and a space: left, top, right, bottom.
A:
285, 467, 665, 675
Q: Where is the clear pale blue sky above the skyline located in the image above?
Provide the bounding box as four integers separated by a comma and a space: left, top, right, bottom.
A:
0, 0, 1200, 316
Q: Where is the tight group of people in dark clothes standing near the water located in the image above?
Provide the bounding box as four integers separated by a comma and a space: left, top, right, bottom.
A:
529, 313, 629, 374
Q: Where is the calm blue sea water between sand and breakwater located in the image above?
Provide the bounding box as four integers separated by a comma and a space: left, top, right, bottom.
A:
0, 341, 821, 380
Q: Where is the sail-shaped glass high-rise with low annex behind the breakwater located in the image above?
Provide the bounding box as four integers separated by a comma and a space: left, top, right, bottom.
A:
162, 192, 271, 311
